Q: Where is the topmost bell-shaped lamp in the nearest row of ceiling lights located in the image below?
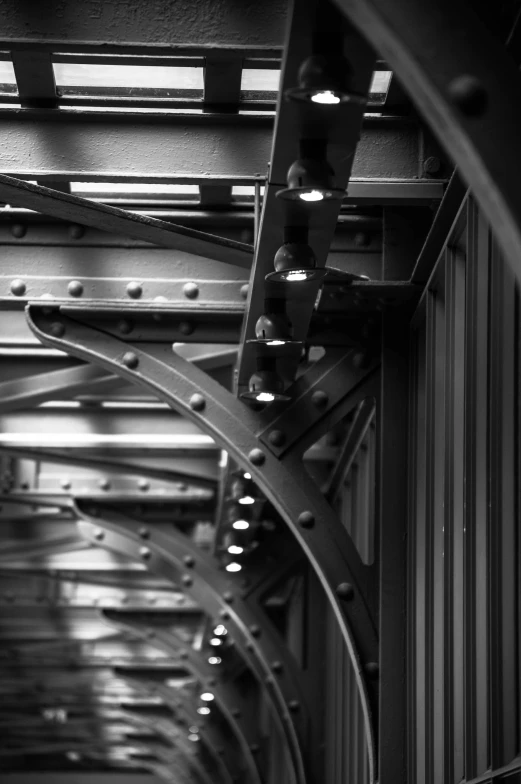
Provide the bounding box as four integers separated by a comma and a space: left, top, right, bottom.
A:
285, 54, 367, 106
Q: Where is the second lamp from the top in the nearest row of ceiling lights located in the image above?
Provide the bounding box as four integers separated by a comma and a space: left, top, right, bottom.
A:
276, 139, 345, 202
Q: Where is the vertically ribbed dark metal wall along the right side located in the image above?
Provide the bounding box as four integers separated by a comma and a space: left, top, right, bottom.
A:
408, 200, 521, 784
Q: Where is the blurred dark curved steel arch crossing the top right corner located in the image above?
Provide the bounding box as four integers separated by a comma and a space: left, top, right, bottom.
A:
334, 0, 521, 280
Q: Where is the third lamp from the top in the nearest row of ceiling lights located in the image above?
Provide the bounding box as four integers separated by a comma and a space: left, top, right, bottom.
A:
264, 226, 327, 284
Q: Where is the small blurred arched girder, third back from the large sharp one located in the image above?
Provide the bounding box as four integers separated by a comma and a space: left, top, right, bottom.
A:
102, 610, 264, 784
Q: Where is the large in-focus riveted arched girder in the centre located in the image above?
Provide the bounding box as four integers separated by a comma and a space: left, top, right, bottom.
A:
27, 305, 378, 782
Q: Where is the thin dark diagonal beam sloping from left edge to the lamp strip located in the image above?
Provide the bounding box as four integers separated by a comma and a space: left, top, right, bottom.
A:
0, 174, 253, 269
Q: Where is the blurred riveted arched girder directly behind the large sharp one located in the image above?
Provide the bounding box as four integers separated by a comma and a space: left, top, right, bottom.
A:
71, 502, 302, 781
